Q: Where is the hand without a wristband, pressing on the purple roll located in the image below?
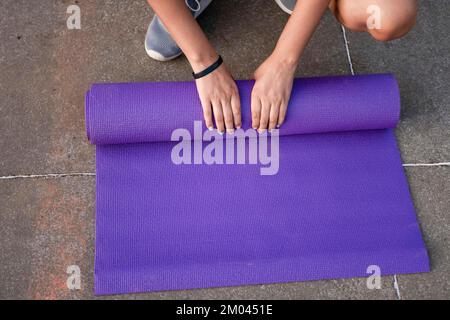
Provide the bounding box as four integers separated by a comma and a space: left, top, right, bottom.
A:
251, 53, 297, 133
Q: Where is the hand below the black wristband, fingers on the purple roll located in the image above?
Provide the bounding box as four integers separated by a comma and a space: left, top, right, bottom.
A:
196, 64, 242, 134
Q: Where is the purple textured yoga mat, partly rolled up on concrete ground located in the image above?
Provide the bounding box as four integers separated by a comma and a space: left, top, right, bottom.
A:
86, 75, 429, 295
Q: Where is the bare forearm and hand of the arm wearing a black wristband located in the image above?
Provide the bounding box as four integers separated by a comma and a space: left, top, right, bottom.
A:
148, 0, 241, 133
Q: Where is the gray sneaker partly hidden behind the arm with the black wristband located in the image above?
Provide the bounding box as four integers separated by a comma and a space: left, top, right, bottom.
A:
145, 0, 212, 61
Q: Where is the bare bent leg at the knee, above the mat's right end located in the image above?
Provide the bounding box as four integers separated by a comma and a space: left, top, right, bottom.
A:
330, 0, 417, 41
